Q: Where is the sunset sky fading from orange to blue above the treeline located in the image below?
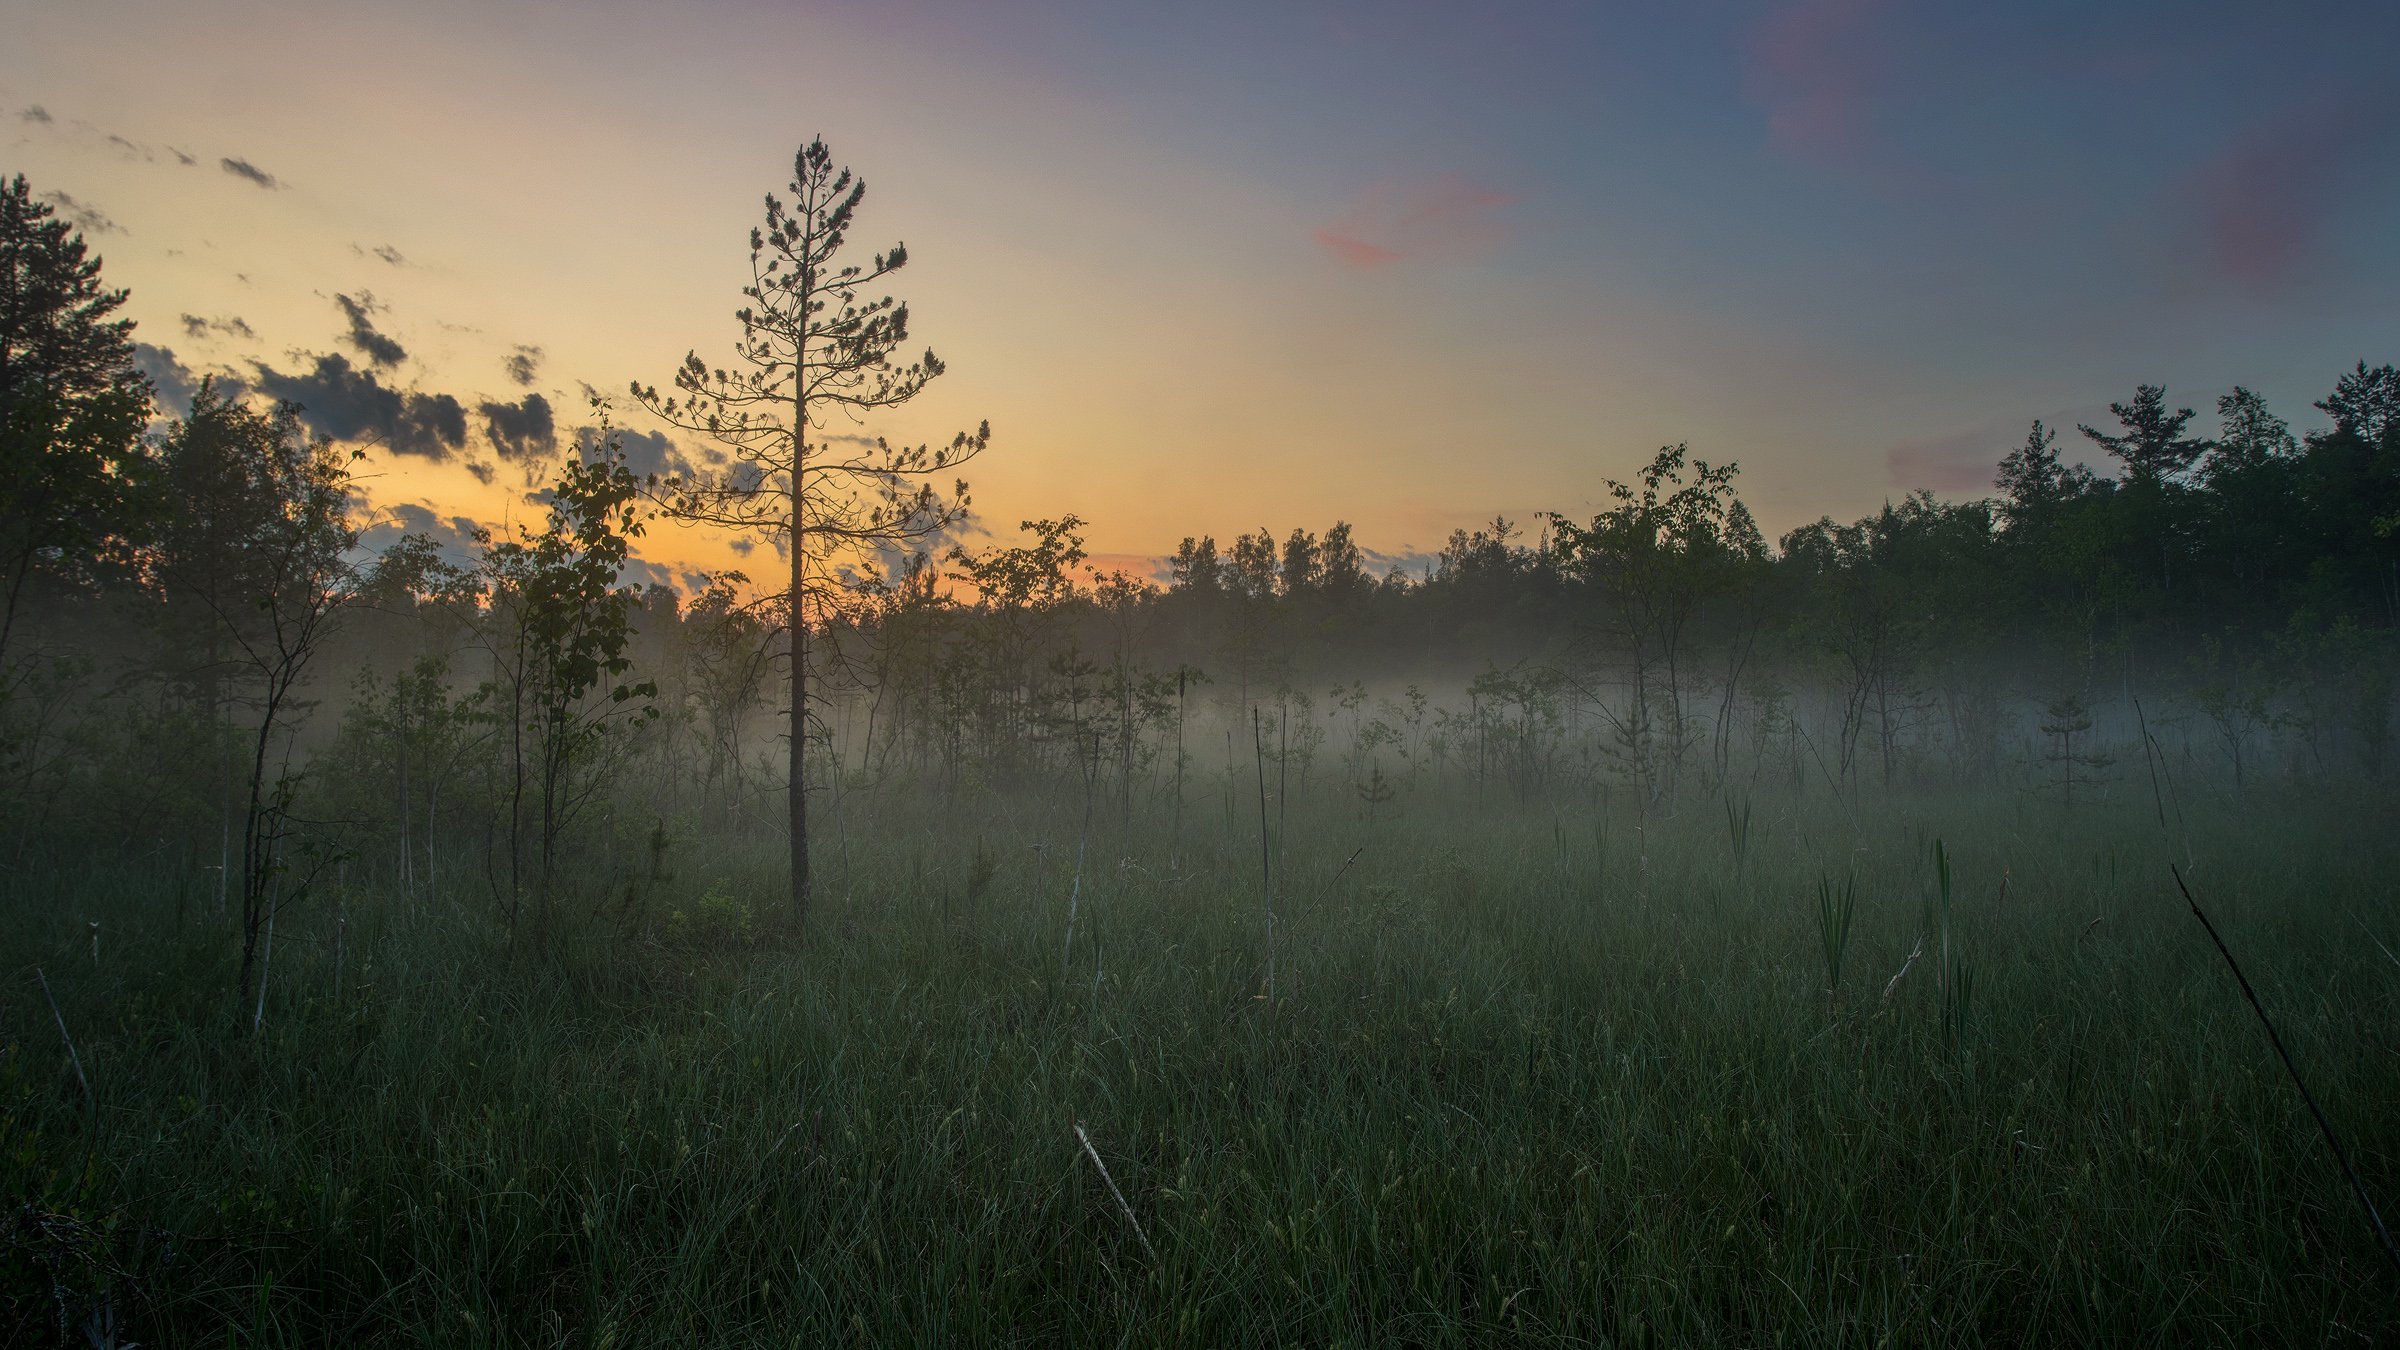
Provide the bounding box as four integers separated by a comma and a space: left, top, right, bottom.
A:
0, 0, 2400, 581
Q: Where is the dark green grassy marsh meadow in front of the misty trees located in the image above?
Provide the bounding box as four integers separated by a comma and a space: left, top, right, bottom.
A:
0, 790, 2400, 1348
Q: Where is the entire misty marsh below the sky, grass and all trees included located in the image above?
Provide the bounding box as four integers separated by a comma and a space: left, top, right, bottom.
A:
0, 147, 2400, 1345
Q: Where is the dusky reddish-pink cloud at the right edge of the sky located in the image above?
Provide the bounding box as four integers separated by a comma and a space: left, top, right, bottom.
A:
2172, 89, 2400, 293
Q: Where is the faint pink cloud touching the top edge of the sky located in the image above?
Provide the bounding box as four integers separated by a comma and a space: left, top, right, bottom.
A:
1747, 0, 1894, 163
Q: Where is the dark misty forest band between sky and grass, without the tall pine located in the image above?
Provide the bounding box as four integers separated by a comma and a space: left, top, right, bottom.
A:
0, 165, 2400, 913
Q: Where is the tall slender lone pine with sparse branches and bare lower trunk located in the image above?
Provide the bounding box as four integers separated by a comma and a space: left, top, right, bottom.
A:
634, 139, 991, 920
